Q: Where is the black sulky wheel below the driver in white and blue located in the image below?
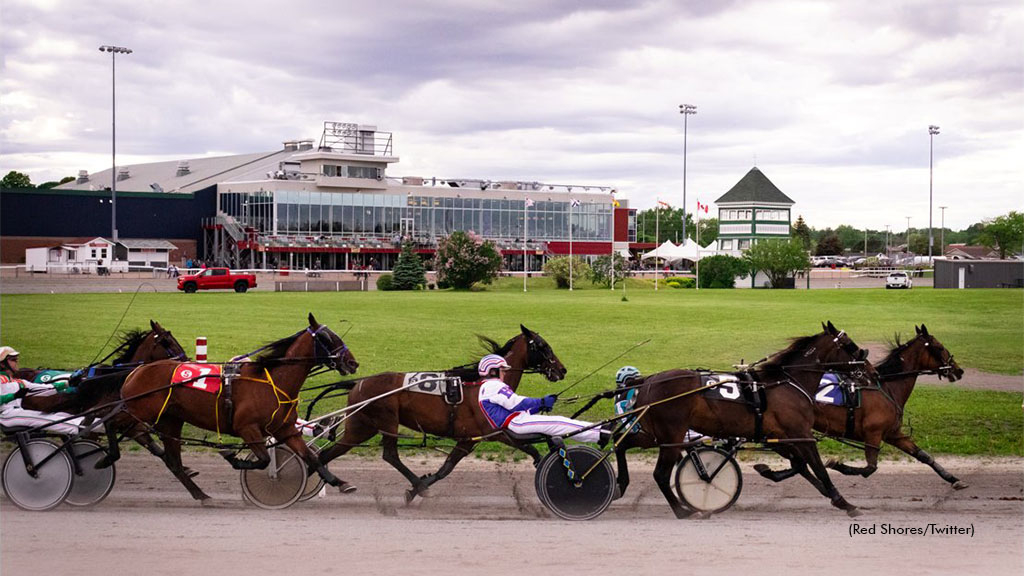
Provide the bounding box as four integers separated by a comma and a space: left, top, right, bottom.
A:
535, 446, 615, 520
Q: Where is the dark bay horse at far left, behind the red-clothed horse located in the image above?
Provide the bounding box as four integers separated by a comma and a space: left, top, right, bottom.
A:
18, 320, 188, 414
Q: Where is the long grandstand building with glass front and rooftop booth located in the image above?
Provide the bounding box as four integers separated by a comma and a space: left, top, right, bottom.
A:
3, 122, 636, 270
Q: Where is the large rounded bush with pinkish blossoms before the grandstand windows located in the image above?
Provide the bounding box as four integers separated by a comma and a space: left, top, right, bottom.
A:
434, 231, 502, 290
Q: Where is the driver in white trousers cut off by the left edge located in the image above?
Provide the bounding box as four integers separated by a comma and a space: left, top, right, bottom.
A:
0, 346, 90, 436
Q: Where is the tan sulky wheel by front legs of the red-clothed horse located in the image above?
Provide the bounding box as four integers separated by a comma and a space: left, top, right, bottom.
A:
241, 445, 306, 510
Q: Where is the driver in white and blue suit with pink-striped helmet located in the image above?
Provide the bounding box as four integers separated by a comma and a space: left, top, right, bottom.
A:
477, 354, 610, 445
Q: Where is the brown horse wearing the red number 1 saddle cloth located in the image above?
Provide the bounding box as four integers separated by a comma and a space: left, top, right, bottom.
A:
115, 314, 358, 501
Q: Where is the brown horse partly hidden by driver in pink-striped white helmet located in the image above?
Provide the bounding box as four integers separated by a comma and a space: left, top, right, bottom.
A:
321, 325, 566, 502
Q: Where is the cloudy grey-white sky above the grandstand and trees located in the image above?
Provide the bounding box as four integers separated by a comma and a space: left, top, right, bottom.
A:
0, 0, 1024, 230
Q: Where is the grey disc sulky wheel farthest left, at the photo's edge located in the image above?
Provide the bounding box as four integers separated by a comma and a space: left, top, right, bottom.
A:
3, 439, 75, 511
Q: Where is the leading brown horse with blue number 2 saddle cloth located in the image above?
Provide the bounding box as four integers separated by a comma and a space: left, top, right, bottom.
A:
755, 324, 968, 490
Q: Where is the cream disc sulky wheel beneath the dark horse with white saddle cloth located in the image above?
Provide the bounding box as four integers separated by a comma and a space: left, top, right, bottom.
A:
675, 446, 743, 513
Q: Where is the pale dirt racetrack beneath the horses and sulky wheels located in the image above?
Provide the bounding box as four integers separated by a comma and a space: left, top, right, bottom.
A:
0, 452, 1024, 576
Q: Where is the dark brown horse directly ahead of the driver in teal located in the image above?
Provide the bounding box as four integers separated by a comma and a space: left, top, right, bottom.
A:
615, 322, 867, 519
